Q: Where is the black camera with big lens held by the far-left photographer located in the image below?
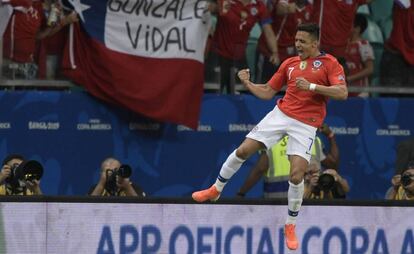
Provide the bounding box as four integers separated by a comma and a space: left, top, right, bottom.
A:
5, 160, 43, 186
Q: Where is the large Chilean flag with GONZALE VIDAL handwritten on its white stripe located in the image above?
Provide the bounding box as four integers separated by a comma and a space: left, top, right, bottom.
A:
63, 0, 210, 128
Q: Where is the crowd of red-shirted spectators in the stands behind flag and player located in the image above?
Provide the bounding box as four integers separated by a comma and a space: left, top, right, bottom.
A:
1, 0, 414, 94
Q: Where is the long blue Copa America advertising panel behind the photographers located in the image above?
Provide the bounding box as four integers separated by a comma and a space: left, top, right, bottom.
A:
0, 91, 414, 199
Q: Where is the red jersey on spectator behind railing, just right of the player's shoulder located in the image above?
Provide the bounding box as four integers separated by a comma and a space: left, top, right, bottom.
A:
345, 40, 375, 96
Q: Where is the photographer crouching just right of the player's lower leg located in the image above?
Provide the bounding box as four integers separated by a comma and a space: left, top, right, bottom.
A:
303, 161, 349, 199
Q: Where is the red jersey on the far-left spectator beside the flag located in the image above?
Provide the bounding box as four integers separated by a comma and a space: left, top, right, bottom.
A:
3, 1, 45, 63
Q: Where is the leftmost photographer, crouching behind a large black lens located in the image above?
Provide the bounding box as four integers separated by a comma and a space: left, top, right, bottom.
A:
0, 154, 43, 195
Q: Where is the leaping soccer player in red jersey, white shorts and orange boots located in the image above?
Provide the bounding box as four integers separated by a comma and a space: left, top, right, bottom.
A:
192, 23, 348, 250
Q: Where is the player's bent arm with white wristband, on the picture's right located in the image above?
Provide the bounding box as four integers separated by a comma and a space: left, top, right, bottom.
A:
296, 61, 348, 100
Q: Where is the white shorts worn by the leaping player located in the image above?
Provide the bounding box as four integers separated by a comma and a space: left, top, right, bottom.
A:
246, 106, 317, 162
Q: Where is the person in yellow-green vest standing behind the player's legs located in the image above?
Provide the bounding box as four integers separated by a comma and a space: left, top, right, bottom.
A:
237, 124, 339, 198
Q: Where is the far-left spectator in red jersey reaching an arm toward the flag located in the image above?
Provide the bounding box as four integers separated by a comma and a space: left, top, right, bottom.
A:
3, 0, 76, 79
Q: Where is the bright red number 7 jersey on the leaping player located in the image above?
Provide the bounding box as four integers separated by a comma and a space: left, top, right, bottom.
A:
268, 53, 346, 127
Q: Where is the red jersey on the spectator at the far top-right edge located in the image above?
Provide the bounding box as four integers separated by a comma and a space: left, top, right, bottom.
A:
387, 0, 414, 65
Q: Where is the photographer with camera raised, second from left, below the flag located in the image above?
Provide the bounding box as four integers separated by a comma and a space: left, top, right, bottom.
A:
89, 157, 145, 198
